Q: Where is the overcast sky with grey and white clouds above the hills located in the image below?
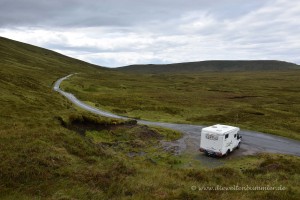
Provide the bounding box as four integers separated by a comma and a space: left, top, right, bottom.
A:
0, 0, 300, 67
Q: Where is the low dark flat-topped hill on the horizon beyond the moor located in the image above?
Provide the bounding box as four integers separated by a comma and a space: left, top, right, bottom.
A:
116, 60, 300, 73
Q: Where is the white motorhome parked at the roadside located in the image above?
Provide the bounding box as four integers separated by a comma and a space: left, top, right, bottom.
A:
199, 124, 242, 156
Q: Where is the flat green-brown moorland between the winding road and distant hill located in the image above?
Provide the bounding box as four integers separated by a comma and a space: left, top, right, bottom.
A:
62, 70, 300, 140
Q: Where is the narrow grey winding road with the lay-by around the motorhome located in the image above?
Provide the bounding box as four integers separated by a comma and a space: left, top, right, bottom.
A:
53, 74, 300, 161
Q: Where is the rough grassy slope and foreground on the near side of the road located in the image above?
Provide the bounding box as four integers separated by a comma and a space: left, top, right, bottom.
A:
0, 38, 300, 199
